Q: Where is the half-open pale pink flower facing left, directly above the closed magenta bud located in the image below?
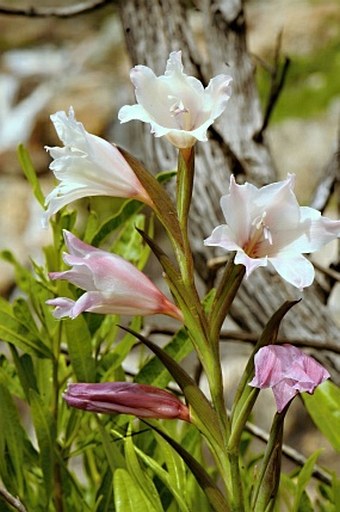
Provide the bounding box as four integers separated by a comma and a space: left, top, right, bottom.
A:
47, 231, 183, 321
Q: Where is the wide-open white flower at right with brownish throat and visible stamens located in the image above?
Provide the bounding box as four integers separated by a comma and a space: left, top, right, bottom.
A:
204, 175, 340, 289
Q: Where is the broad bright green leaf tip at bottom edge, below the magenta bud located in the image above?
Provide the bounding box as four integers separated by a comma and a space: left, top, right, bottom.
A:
113, 469, 156, 512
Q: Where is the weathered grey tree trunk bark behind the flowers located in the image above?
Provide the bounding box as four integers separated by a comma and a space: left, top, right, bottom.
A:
119, 0, 340, 382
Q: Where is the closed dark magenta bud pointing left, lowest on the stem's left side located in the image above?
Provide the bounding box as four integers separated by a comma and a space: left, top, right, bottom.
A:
63, 382, 190, 421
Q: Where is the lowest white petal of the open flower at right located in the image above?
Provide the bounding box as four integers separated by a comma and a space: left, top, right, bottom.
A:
268, 254, 315, 290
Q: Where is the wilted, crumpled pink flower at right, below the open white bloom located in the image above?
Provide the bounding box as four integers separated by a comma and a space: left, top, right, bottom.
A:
249, 344, 330, 412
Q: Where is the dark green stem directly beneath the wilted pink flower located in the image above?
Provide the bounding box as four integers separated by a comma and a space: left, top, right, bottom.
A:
251, 403, 290, 512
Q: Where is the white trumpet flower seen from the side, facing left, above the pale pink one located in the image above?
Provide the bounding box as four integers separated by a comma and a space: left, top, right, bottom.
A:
44, 107, 151, 223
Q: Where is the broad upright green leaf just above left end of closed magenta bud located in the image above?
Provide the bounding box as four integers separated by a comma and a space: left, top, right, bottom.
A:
63, 316, 96, 382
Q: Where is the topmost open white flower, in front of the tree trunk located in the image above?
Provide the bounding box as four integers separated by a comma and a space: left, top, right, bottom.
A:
118, 51, 232, 148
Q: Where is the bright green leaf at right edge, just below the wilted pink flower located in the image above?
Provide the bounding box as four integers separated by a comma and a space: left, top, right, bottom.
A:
301, 380, 340, 452
